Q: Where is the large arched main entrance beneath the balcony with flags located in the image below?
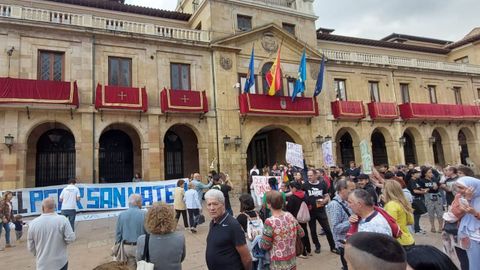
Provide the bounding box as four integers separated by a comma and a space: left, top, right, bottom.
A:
247, 127, 298, 172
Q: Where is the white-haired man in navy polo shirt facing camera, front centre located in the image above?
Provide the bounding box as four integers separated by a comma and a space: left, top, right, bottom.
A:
205, 189, 252, 270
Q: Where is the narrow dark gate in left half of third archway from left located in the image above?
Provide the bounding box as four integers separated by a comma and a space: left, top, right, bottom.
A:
164, 131, 185, 180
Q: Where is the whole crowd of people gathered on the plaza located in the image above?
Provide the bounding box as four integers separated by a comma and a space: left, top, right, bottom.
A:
0, 161, 480, 270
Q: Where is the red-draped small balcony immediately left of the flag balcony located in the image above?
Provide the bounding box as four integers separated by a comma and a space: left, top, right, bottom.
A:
160, 88, 208, 114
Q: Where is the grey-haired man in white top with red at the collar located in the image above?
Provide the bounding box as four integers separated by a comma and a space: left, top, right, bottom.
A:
348, 189, 392, 236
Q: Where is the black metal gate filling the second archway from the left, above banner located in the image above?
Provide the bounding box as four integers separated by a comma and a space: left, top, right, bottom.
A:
98, 130, 133, 183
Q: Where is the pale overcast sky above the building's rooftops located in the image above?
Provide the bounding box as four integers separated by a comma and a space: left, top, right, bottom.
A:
126, 0, 480, 41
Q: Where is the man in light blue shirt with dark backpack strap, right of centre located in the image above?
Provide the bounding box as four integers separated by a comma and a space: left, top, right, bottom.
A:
327, 179, 355, 270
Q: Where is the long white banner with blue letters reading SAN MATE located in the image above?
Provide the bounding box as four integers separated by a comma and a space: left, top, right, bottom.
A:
0, 179, 188, 216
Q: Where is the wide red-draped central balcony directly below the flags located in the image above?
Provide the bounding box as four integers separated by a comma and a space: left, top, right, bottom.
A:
238, 93, 318, 117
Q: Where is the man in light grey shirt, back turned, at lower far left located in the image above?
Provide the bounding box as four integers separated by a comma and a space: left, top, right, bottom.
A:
28, 197, 75, 270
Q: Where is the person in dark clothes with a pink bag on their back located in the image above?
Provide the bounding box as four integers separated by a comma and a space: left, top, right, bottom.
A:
287, 182, 312, 259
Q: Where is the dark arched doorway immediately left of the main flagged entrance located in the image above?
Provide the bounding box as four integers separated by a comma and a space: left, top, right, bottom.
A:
163, 125, 200, 180
